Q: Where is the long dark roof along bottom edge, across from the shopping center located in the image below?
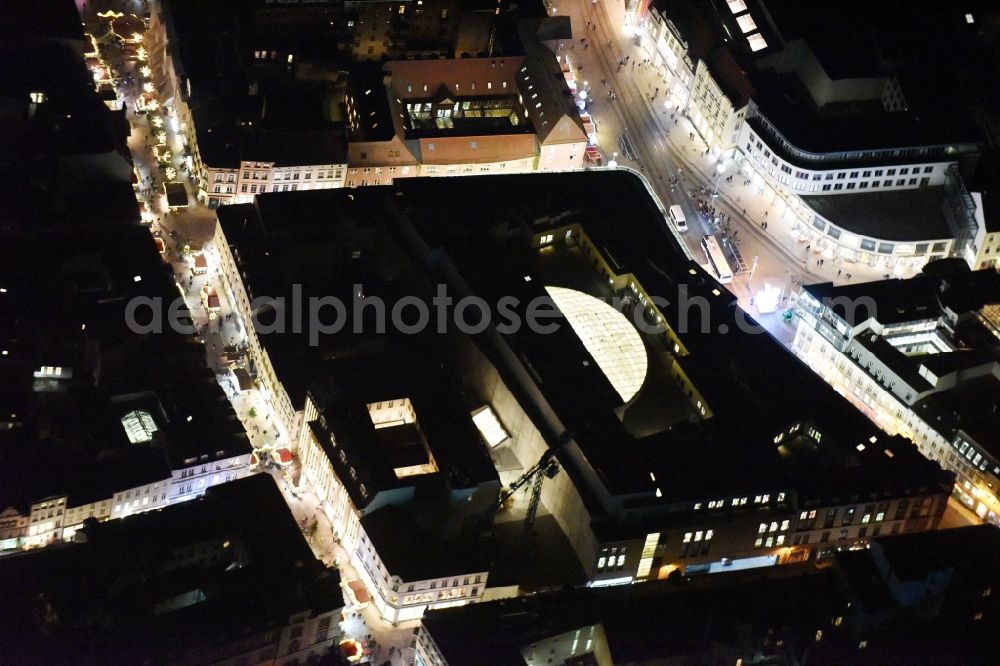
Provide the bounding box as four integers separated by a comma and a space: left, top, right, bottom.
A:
423, 574, 847, 666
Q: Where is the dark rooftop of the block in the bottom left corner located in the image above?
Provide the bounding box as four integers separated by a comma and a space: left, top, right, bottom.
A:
0, 474, 343, 663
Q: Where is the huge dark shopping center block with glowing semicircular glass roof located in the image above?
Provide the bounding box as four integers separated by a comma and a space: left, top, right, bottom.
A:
209, 171, 953, 600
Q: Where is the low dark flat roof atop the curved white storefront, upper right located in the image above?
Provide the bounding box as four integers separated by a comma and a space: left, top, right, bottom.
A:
802, 188, 953, 243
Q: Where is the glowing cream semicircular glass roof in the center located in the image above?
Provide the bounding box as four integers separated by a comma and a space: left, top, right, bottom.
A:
545, 287, 647, 402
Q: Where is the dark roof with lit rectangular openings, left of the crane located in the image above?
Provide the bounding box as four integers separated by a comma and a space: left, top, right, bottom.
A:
300, 335, 496, 508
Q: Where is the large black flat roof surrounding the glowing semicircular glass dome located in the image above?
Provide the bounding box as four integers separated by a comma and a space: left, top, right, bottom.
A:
395, 172, 947, 502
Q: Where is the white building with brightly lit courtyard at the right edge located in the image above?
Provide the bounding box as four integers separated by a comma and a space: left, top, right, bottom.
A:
792, 272, 1000, 524
